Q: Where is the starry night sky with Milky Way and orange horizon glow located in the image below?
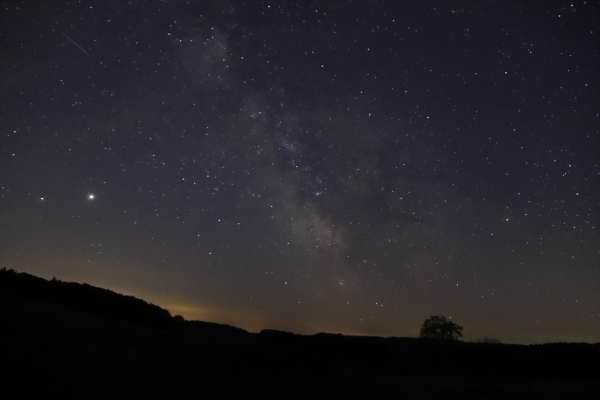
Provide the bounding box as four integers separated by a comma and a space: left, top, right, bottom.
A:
0, 0, 600, 343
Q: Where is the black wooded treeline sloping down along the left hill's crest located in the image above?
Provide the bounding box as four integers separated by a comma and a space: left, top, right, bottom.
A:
0, 268, 247, 333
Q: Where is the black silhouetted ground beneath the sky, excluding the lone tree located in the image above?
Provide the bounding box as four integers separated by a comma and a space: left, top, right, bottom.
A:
0, 270, 600, 399
